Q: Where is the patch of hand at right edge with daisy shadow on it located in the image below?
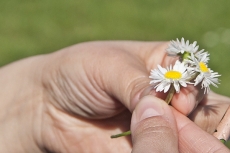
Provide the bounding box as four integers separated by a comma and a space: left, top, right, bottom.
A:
189, 91, 230, 140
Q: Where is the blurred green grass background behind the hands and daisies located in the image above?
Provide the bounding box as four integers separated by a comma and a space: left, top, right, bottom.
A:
0, 0, 230, 147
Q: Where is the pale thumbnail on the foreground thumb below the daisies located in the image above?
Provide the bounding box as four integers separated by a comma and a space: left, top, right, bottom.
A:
136, 95, 164, 122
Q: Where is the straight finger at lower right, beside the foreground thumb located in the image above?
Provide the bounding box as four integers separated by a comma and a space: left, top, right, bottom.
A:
173, 110, 230, 153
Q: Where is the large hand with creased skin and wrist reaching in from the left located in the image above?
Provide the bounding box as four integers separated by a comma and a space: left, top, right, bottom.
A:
0, 41, 226, 152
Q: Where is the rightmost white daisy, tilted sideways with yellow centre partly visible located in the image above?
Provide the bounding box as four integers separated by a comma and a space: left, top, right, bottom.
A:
191, 53, 221, 93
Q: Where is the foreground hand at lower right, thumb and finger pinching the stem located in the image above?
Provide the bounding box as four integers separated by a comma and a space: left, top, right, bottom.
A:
131, 95, 230, 153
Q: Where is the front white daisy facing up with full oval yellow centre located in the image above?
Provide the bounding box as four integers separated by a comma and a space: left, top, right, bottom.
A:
149, 60, 193, 93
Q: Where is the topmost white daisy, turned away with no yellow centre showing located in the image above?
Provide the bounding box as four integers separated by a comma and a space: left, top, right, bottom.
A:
166, 38, 199, 56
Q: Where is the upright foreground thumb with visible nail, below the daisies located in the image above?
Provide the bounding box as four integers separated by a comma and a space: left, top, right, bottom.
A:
131, 95, 178, 153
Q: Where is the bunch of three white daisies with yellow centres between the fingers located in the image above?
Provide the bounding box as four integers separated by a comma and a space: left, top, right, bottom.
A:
149, 38, 220, 93
